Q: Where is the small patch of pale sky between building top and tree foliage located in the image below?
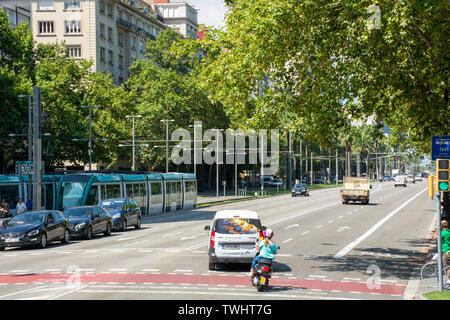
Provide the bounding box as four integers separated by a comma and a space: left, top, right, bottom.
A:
187, 0, 225, 27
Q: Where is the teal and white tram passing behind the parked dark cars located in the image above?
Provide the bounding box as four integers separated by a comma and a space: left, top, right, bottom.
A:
0, 173, 197, 214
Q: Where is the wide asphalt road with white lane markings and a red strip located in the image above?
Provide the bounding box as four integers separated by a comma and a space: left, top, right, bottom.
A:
0, 180, 435, 300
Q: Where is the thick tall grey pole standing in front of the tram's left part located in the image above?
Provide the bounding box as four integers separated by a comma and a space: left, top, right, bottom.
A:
30, 87, 42, 211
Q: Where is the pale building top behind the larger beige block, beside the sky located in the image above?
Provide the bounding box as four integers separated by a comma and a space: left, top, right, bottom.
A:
146, 0, 198, 39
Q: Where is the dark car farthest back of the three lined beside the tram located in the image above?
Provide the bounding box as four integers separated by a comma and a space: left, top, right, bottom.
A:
98, 198, 142, 231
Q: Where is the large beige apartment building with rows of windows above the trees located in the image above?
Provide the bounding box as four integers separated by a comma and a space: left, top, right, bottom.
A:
31, 0, 167, 85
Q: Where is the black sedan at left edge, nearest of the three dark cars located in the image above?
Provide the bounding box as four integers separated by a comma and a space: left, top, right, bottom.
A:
0, 211, 70, 250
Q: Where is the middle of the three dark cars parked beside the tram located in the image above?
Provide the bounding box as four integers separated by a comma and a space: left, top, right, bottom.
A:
64, 206, 112, 239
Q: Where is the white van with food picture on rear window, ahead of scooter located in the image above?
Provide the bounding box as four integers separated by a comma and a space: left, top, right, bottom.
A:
205, 210, 263, 270
